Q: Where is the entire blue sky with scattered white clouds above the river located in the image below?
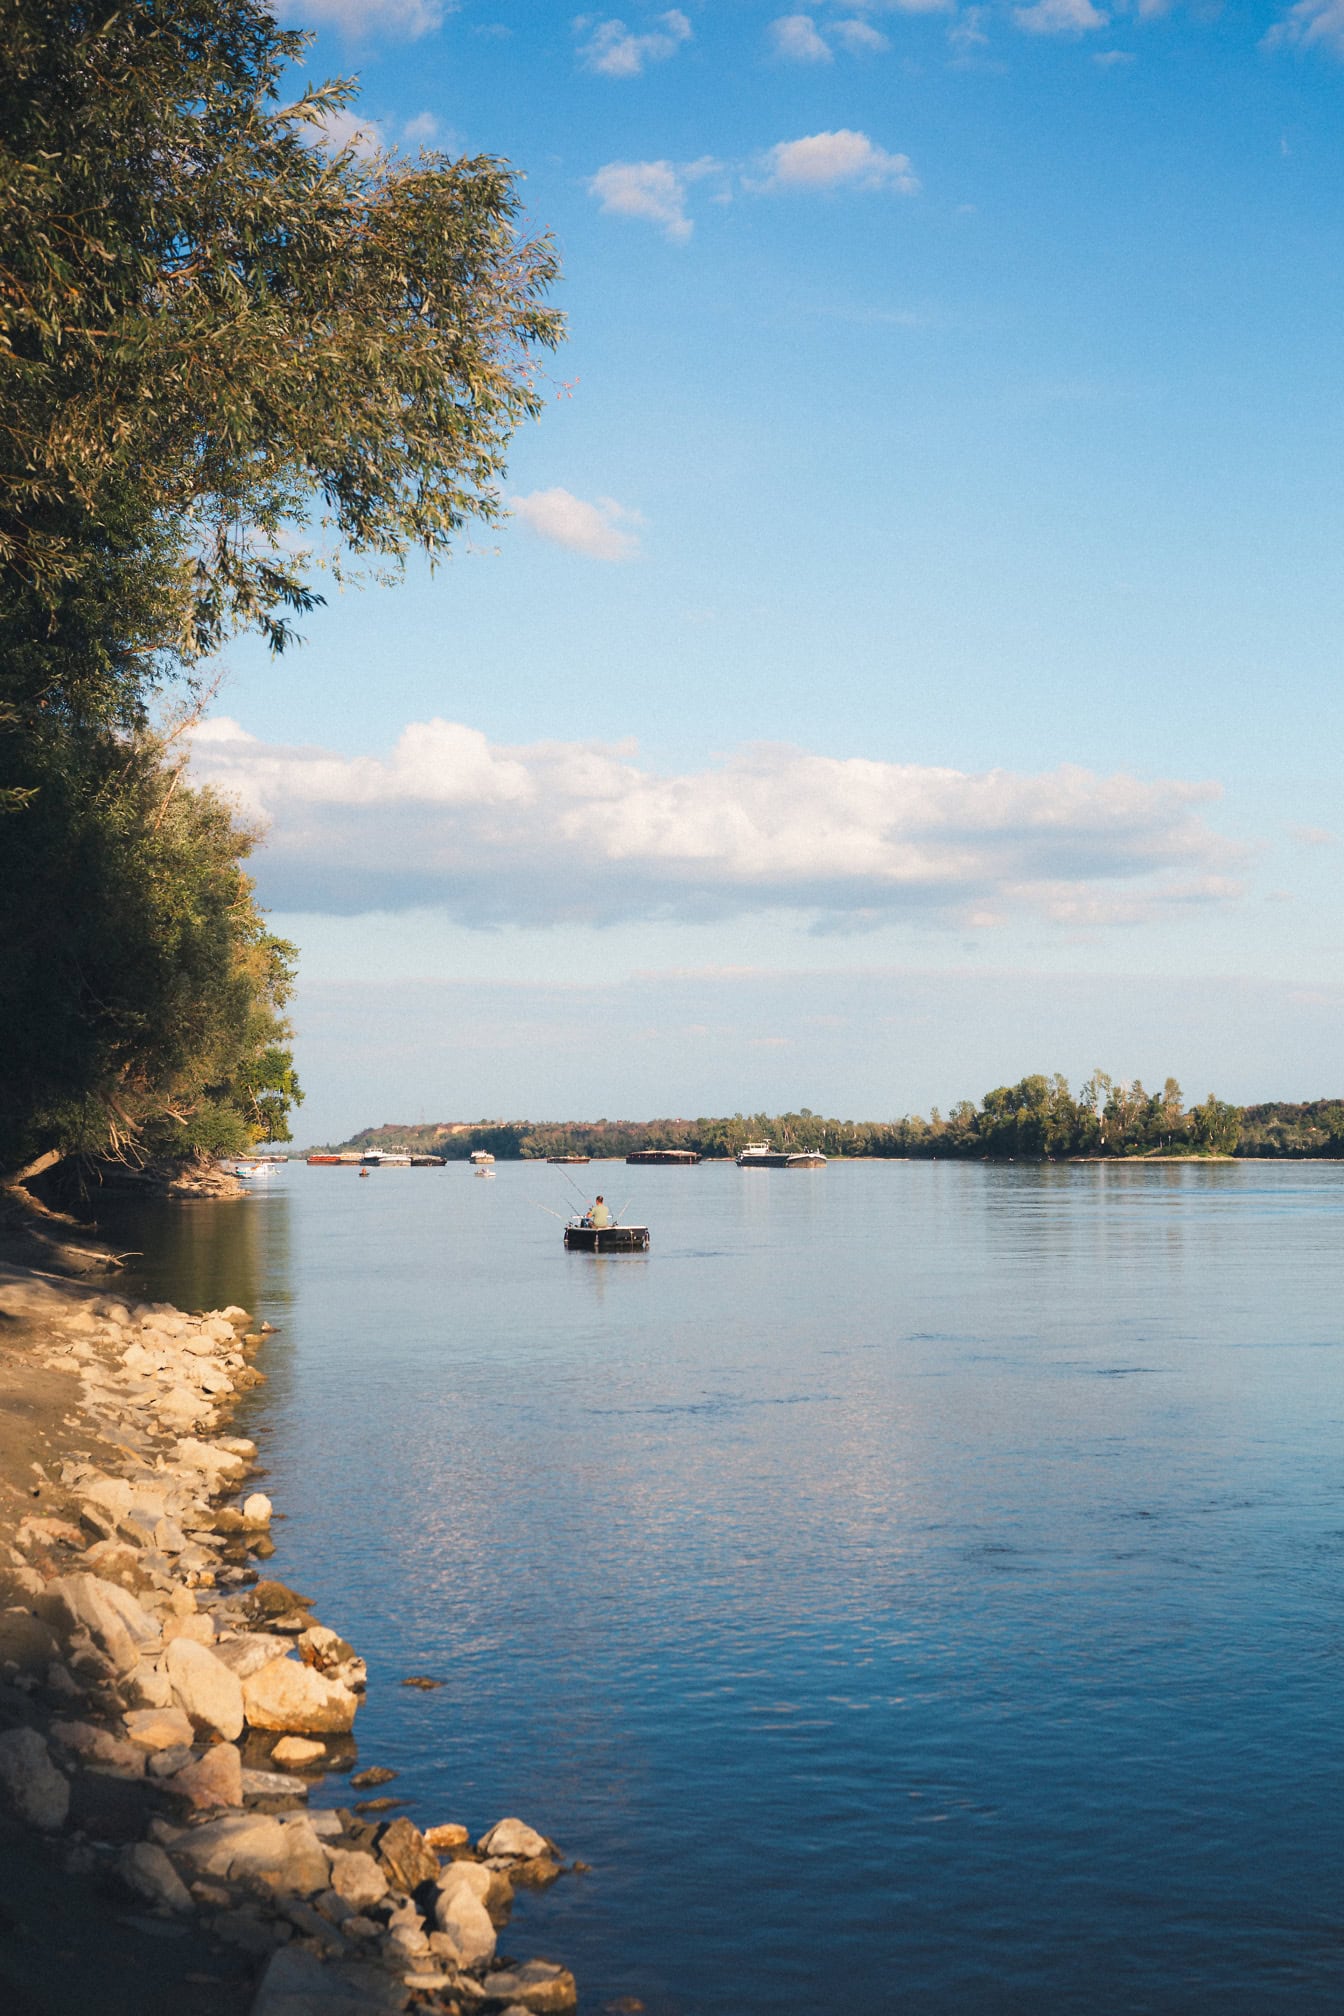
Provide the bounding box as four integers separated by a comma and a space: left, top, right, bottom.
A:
197, 0, 1344, 1139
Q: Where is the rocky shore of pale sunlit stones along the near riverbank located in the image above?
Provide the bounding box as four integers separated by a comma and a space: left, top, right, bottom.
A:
0, 1268, 576, 2016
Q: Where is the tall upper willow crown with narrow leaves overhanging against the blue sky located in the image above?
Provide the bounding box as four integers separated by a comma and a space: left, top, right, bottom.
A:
0, 0, 560, 1161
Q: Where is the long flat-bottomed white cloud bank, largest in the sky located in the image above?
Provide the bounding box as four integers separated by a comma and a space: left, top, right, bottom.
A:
191, 720, 1237, 929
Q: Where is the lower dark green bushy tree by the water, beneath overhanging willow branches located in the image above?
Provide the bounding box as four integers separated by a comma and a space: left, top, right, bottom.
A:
0, 717, 300, 1165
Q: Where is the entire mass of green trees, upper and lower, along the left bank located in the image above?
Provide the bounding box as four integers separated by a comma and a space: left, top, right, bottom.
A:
0, 0, 560, 1181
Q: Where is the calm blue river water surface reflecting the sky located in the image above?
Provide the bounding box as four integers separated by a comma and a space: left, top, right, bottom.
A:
118, 1163, 1344, 2016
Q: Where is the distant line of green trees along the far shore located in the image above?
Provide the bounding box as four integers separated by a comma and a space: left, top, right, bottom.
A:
322, 1070, 1344, 1161
